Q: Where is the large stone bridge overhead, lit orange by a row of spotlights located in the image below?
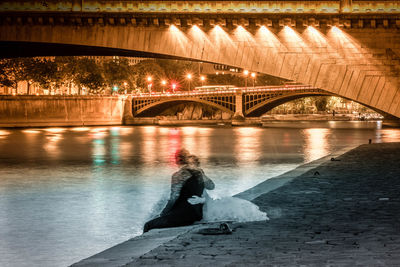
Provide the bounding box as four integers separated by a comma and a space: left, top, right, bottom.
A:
0, 0, 400, 118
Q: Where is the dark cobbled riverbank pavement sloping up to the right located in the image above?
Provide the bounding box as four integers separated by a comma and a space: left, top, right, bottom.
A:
73, 143, 400, 266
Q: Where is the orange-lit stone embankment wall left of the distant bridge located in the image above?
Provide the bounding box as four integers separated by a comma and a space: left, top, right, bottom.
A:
0, 96, 125, 127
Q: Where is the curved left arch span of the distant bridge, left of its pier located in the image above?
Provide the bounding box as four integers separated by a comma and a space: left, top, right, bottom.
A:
133, 98, 234, 117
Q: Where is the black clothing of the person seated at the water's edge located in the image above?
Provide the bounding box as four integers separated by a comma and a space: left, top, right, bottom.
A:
143, 170, 204, 232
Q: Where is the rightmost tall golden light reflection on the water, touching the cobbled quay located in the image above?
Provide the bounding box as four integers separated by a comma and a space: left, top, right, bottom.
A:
303, 128, 330, 162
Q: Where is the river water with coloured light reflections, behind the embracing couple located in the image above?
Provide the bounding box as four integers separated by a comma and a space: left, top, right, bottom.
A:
0, 122, 400, 266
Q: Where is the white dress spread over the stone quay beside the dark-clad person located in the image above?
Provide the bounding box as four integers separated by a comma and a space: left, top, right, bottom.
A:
203, 191, 269, 222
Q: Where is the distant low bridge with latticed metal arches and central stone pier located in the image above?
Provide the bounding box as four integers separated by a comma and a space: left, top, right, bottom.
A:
132, 85, 332, 118
